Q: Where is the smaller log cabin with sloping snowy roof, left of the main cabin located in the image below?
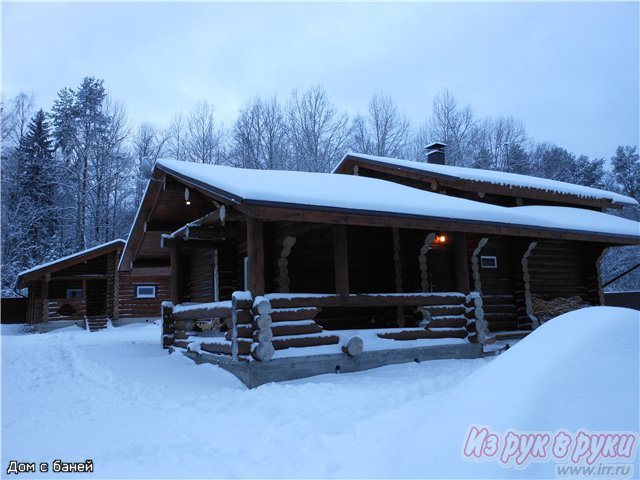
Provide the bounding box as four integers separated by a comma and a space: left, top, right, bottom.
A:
16, 240, 170, 332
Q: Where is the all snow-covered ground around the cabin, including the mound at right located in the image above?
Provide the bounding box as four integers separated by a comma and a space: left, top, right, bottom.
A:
2, 307, 640, 478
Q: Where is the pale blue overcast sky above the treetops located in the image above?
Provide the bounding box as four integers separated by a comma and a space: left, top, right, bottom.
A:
2, 2, 640, 157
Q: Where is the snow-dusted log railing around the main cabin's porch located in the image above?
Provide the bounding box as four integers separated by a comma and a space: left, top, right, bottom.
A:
162, 292, 487, 360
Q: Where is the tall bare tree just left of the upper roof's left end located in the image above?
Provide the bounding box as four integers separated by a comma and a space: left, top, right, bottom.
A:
287, 86, 349, 172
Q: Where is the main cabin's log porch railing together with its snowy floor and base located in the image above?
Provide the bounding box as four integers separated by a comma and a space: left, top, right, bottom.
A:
162, 292, 486, 387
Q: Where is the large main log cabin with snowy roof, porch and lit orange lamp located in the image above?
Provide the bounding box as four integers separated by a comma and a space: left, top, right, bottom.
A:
120, 155, 640, 386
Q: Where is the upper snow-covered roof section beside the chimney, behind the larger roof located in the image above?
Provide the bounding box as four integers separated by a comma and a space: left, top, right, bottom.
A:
333, 153, 638, 205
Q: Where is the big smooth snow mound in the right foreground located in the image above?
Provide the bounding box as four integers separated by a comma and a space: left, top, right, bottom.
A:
330, 307, 640, 478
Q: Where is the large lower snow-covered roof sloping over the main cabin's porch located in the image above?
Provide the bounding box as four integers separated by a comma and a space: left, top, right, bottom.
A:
158, 160, 640, 241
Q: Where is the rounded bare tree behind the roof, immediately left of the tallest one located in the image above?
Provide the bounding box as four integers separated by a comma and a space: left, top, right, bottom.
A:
231, 96, 289, 170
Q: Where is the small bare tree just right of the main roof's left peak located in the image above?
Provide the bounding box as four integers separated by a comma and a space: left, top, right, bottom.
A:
183, 102, 224, 163
